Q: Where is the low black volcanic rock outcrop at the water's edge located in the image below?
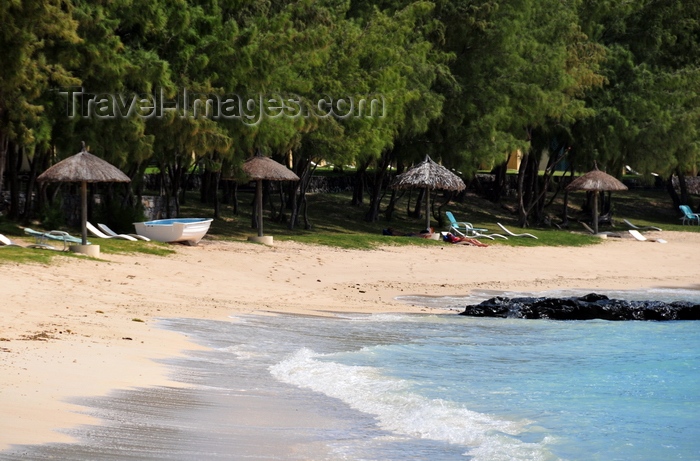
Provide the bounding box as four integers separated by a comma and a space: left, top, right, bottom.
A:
460, 293, 700, 320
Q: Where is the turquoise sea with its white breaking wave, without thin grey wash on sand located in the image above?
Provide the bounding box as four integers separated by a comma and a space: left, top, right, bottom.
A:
180, 290, 700, 461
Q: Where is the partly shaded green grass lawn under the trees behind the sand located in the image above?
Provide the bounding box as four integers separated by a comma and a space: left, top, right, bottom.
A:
0, 183, 700, 264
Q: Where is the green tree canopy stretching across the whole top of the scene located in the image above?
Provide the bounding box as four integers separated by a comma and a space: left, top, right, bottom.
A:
0, 0, 700, 225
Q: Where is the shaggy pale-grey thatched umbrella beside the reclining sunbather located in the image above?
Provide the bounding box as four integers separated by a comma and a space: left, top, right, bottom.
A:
391, 155, 467, 231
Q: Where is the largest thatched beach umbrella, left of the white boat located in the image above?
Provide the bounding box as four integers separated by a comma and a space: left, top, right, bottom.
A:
37, 142, 131, 245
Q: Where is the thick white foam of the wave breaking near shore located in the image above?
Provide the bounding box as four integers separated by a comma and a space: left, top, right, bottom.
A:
270, 348, 553, 461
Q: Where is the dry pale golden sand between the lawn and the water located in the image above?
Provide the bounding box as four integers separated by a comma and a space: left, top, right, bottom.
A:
0, 232, 700, 450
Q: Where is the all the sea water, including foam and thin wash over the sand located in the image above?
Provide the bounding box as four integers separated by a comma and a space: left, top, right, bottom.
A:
0, 290, 700, 461
